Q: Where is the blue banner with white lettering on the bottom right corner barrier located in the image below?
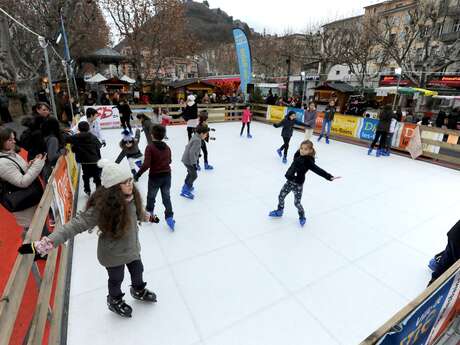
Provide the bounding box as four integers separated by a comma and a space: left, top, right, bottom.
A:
377, 272, 460, 345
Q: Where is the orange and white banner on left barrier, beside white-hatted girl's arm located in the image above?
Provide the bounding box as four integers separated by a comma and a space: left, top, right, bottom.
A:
53, 158, 73, 224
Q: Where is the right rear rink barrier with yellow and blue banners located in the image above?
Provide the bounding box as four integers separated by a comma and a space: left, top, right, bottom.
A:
252, 104, 460, 169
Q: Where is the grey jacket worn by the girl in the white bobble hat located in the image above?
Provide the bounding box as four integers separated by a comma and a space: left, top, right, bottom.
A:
48, 199, 143, 267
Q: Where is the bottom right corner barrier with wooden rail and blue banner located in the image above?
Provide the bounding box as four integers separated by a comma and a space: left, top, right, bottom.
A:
360, 260, 460, 345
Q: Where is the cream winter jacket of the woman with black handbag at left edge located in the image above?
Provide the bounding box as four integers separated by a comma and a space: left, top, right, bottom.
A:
0, 151, 45, 228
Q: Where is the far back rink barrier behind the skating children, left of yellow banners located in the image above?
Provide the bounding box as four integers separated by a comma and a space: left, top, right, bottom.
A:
84, 103, 246, 128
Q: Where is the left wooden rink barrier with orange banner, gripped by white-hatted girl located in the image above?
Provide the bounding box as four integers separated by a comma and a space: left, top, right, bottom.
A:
0, 152, 79, 345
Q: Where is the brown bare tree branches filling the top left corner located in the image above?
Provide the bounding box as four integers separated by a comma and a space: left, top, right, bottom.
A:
0, 0, 108, 105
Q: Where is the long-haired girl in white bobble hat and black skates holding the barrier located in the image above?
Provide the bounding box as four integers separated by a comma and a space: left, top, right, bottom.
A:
19, 160, 157, 317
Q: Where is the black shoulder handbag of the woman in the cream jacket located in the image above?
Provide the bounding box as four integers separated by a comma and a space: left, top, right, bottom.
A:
0, 156, 43, 212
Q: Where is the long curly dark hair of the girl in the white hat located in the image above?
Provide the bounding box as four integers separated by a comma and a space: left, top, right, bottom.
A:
86, 184, 145, 239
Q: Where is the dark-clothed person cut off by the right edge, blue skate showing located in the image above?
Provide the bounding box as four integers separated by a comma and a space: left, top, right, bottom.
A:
428, 220, 460, 285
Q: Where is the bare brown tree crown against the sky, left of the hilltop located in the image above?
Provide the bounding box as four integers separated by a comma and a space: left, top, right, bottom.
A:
101, 0, 196, 84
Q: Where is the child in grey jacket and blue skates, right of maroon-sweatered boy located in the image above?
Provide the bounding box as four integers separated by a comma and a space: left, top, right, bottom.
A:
180, 126, 209, 199
